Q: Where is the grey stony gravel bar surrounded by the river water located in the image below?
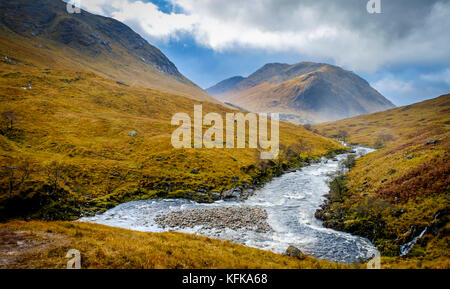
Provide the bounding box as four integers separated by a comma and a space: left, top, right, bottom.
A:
155, 206, 272, 233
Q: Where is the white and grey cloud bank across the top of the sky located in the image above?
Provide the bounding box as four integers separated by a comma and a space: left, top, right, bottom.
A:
77, 0, 450, 73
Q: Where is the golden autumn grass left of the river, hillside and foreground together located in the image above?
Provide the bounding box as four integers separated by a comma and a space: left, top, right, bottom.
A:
0, 23, 344, 268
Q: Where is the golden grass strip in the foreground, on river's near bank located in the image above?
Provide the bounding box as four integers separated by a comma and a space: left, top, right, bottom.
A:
0, 221, 350, 269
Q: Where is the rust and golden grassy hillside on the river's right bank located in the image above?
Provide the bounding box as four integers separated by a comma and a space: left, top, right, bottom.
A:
315, 95, 450, 268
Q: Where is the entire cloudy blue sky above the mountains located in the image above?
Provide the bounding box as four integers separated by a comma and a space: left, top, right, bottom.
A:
69, 0, 450, 105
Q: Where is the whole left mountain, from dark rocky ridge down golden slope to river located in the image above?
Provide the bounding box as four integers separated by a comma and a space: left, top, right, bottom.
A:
0, 0, 342, 220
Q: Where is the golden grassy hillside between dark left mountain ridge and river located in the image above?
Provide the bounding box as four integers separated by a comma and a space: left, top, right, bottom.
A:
0, 54, 342, 219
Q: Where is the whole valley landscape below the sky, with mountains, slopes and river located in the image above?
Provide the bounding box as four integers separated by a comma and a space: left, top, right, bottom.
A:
0, 0, 450, 269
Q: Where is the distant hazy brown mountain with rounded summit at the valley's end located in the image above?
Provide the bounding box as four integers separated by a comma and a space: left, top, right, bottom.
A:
206, 62, 394, 122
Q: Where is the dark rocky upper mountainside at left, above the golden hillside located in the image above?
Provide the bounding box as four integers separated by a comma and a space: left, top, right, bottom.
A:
0, 0, 217, 103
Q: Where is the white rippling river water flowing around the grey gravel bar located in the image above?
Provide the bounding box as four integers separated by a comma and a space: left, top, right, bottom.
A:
79, 147, 377, 264
